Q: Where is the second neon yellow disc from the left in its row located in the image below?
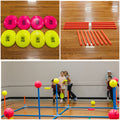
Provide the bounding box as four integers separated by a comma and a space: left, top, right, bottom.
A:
16, 30, 30, 48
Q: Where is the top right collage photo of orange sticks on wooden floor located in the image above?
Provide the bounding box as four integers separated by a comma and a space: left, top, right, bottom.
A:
61, 1, 119, 60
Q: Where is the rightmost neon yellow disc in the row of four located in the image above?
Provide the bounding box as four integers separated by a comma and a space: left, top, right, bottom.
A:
45, 30, 60, 48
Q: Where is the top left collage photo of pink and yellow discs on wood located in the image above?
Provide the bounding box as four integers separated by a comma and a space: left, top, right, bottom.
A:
1, 0, 60, 59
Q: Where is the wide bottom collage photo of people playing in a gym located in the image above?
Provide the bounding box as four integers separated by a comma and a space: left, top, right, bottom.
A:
1, 61, 119, 119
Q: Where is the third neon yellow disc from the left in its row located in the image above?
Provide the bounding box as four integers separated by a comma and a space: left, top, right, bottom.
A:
31, 30, 45, 48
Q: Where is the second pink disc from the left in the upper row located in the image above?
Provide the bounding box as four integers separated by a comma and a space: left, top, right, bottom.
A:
18, 16, 30, 30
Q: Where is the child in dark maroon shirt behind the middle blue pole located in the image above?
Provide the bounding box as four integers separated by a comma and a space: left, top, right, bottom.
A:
51, 80, 61, 104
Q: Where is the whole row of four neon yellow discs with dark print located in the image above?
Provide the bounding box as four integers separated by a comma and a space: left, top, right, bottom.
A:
1, 30, 59, 48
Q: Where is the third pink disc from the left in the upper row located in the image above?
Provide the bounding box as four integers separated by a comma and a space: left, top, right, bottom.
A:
31, 16, 44, 30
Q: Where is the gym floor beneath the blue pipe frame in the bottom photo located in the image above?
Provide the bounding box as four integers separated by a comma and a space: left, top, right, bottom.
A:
1, 100, 119, 119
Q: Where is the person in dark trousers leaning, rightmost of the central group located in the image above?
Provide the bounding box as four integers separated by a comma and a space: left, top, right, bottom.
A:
64, 71, 77, 101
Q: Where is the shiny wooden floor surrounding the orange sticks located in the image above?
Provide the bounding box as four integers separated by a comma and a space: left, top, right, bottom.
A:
61, 1, 119, 59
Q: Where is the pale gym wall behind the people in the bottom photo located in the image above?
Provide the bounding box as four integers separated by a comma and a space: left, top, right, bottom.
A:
2, 61, 119, 97
